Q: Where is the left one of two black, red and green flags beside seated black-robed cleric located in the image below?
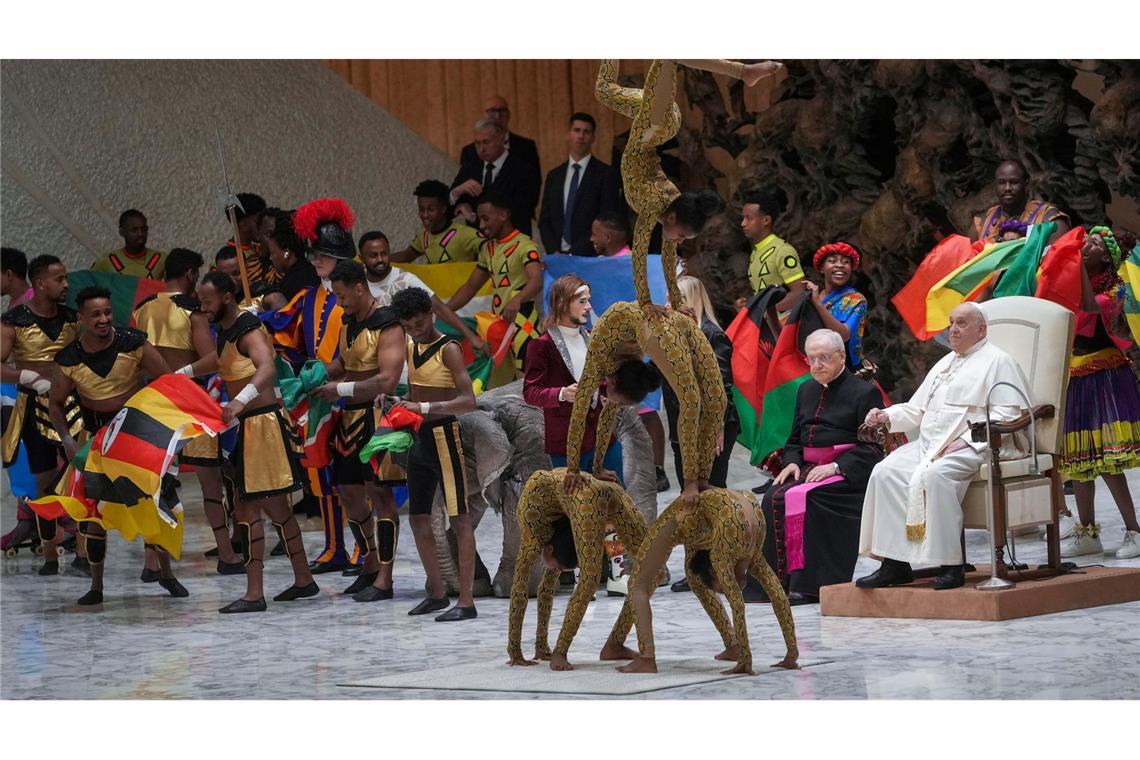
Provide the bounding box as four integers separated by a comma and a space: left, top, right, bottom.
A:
725, 287, 787, 465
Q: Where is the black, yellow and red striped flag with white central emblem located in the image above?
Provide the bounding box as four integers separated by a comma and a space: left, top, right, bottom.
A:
30, 375, 223, 559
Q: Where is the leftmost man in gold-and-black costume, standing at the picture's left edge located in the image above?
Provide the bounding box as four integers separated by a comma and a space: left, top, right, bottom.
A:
0, 254, 78, 575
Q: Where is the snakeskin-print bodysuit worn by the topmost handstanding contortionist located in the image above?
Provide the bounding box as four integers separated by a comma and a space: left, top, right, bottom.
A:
595, 60, 743, 307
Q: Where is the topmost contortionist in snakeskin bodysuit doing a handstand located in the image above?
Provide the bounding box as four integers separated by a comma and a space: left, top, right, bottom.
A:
595, 60, 781, 308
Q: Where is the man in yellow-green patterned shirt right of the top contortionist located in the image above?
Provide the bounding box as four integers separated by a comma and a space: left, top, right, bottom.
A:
738, 186, 806, 310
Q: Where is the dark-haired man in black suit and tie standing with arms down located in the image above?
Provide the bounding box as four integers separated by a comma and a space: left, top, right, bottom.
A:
538, 113, 618, 256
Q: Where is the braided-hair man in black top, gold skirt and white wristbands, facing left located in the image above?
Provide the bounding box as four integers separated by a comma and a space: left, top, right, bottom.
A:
186, 272, 320, 613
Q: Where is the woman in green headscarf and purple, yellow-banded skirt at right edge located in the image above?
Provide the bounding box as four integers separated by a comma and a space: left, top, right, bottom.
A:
1060, 227, 1140, 559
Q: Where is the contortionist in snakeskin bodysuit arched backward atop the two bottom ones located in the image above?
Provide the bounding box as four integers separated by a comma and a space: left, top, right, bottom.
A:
565, 301, 727, 502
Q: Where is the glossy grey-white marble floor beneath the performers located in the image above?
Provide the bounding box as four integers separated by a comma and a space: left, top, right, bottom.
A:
0, 452, 1140, 700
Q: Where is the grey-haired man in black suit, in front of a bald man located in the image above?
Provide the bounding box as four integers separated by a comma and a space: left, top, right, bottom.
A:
450, 119, 543, 236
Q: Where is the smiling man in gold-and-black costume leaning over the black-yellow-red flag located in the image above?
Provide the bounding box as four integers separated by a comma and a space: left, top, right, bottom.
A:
48, 287, 189, 606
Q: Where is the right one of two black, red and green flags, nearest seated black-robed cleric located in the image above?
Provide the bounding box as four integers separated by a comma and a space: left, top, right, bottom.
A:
752, 293, 823, 463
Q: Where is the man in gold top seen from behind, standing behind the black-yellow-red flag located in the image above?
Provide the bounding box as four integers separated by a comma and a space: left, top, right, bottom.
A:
135, 248, 245, 575
